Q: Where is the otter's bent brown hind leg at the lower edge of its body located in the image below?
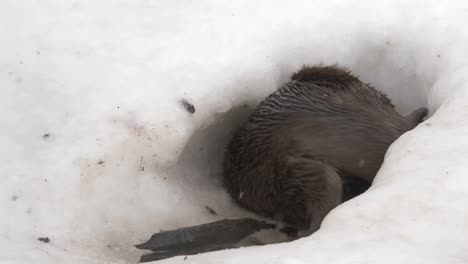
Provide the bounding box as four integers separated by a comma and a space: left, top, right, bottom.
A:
279, 156, 343, 234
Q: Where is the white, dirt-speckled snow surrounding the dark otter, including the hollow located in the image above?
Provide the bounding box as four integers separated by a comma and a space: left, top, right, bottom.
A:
0, 0, 468, 264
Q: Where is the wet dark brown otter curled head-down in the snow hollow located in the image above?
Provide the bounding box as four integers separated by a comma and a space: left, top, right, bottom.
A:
223, 66, 427, 234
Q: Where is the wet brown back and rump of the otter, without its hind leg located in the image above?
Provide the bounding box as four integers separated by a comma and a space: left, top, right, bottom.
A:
224, 66, 409, 219
